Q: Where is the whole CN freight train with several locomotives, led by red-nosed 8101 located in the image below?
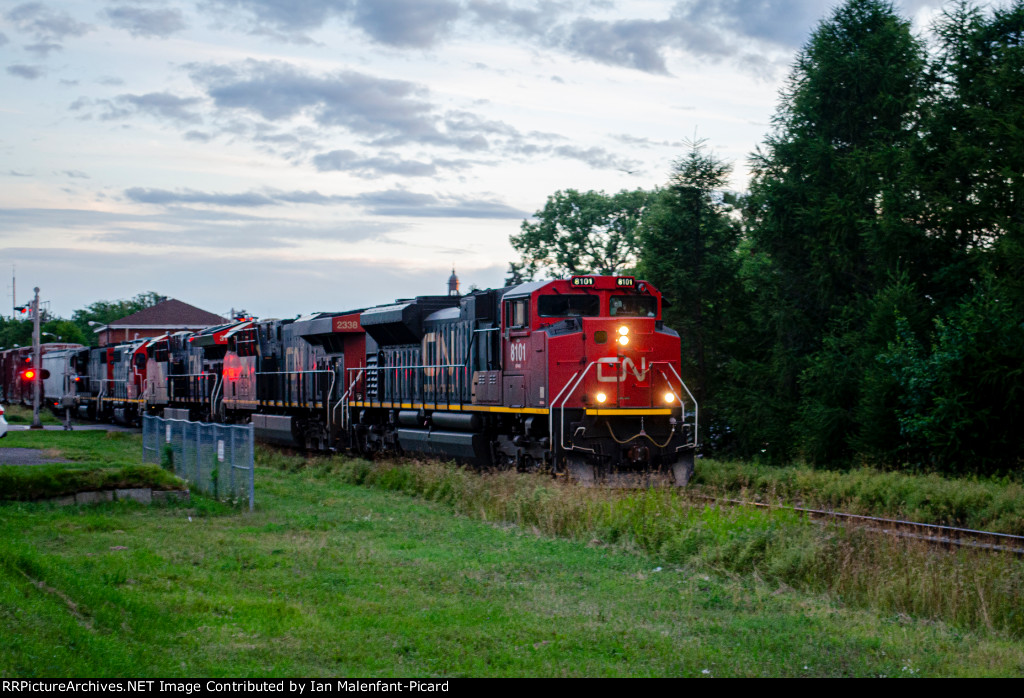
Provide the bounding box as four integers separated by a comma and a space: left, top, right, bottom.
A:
0, 275, 698, 485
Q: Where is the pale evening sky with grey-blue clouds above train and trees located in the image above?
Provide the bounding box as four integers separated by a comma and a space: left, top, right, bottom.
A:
0, 0, 940, 317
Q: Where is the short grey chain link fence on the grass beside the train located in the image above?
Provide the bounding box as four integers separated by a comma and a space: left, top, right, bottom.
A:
142, 415, 256, 511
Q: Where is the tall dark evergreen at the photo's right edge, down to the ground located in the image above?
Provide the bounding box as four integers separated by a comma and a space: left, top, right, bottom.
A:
879, 0, 1024, 472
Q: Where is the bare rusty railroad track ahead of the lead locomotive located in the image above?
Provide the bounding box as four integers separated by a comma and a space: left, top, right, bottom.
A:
681, 491, 1024, 556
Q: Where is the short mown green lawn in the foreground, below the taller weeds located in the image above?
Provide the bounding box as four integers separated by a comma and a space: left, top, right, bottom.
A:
0, 432, 1024, 677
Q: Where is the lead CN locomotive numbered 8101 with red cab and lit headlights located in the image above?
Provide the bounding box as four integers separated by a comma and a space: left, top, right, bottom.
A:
343, 276, 697, 484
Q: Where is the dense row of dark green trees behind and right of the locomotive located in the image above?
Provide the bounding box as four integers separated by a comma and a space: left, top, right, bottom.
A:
509, 0, 1024, 474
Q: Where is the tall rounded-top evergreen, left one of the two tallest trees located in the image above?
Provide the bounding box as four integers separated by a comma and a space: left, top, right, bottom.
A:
740, 0, 928, 460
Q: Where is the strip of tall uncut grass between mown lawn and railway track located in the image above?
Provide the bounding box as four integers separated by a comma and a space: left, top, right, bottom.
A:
257, 451, 1024, 638
